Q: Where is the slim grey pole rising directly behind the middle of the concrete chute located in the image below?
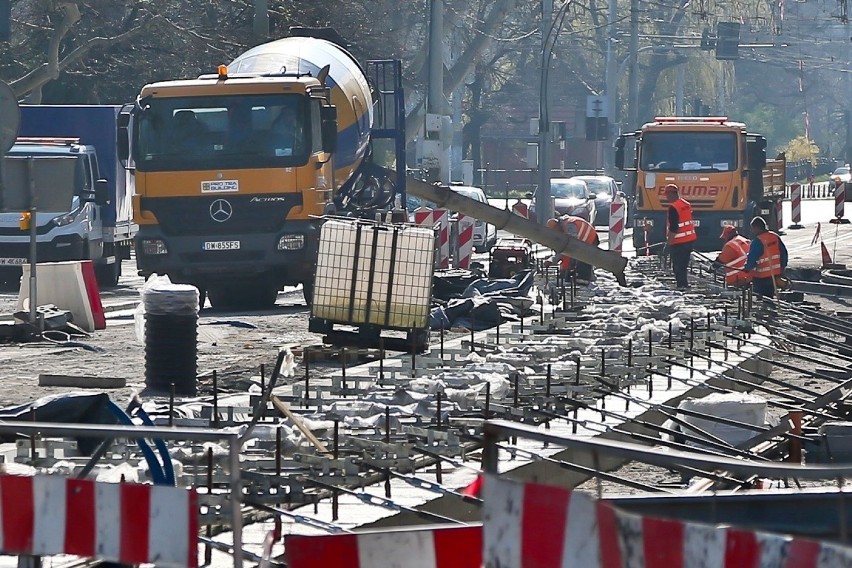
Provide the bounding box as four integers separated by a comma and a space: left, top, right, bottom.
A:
535, 0, 556, 225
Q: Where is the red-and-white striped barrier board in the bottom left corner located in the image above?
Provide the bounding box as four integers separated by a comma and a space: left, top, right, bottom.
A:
0, 475, 198, 568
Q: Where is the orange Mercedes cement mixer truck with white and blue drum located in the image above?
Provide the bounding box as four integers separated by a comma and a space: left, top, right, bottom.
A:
119, 28, 404, 308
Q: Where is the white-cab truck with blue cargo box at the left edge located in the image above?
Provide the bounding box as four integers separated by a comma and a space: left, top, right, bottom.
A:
0, 105, 138, 286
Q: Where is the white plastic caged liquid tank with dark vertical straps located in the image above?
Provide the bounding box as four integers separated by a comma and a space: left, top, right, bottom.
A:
311, 219, 435, 330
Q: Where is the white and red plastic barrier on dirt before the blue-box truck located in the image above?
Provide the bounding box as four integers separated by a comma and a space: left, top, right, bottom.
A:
17, 260, 106, 331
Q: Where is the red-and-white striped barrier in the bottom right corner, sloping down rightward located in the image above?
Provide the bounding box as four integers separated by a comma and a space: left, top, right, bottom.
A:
483, 476, 852, 568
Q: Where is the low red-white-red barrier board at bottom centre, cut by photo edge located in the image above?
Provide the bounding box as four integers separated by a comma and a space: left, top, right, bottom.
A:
284, 526, 482, 568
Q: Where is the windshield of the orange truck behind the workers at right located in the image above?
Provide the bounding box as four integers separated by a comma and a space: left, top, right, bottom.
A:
639, 132, 737, 172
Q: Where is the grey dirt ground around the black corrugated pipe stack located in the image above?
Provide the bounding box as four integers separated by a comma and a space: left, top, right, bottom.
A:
0, 268, 321, 407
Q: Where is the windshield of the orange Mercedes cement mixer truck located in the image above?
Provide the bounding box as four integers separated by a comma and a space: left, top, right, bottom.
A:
134, 95, 311, 171
